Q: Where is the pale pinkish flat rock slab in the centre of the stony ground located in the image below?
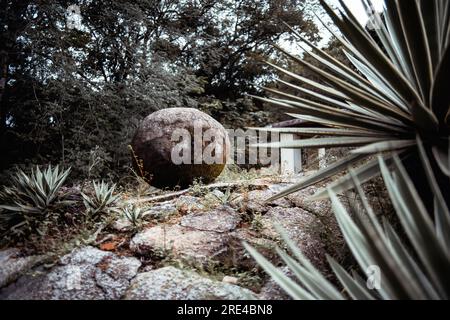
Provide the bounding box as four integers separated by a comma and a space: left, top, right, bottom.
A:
130, 225, 229, 263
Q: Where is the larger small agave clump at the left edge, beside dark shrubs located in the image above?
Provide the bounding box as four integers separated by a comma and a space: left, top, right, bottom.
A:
0, 166, 71, 236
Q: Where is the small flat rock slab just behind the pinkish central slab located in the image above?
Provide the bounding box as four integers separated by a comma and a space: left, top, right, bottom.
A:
180, 206, 241, 233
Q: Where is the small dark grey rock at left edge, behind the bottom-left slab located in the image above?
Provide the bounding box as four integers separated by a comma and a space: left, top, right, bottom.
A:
0, 248, 43, 288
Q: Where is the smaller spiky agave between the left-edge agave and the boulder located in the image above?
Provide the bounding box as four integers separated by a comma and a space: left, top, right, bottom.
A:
81, 181, 120, 220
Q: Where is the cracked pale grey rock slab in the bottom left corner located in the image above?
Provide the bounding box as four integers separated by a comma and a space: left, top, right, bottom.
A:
0, 247, 141, 300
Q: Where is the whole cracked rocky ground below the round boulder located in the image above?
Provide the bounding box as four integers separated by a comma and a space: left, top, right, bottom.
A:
0, 172, 348, 299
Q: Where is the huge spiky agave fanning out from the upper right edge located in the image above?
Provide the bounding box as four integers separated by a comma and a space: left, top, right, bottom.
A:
255, 0, 450, 204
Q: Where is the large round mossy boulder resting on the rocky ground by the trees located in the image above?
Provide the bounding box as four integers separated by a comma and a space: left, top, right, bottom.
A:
131, 108, 230, 188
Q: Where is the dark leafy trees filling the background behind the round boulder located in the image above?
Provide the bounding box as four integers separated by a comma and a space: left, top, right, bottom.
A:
0, 0, 333, 184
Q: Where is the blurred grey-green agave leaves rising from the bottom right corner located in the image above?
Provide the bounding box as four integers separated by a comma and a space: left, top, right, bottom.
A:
246, 140, 450, 300
